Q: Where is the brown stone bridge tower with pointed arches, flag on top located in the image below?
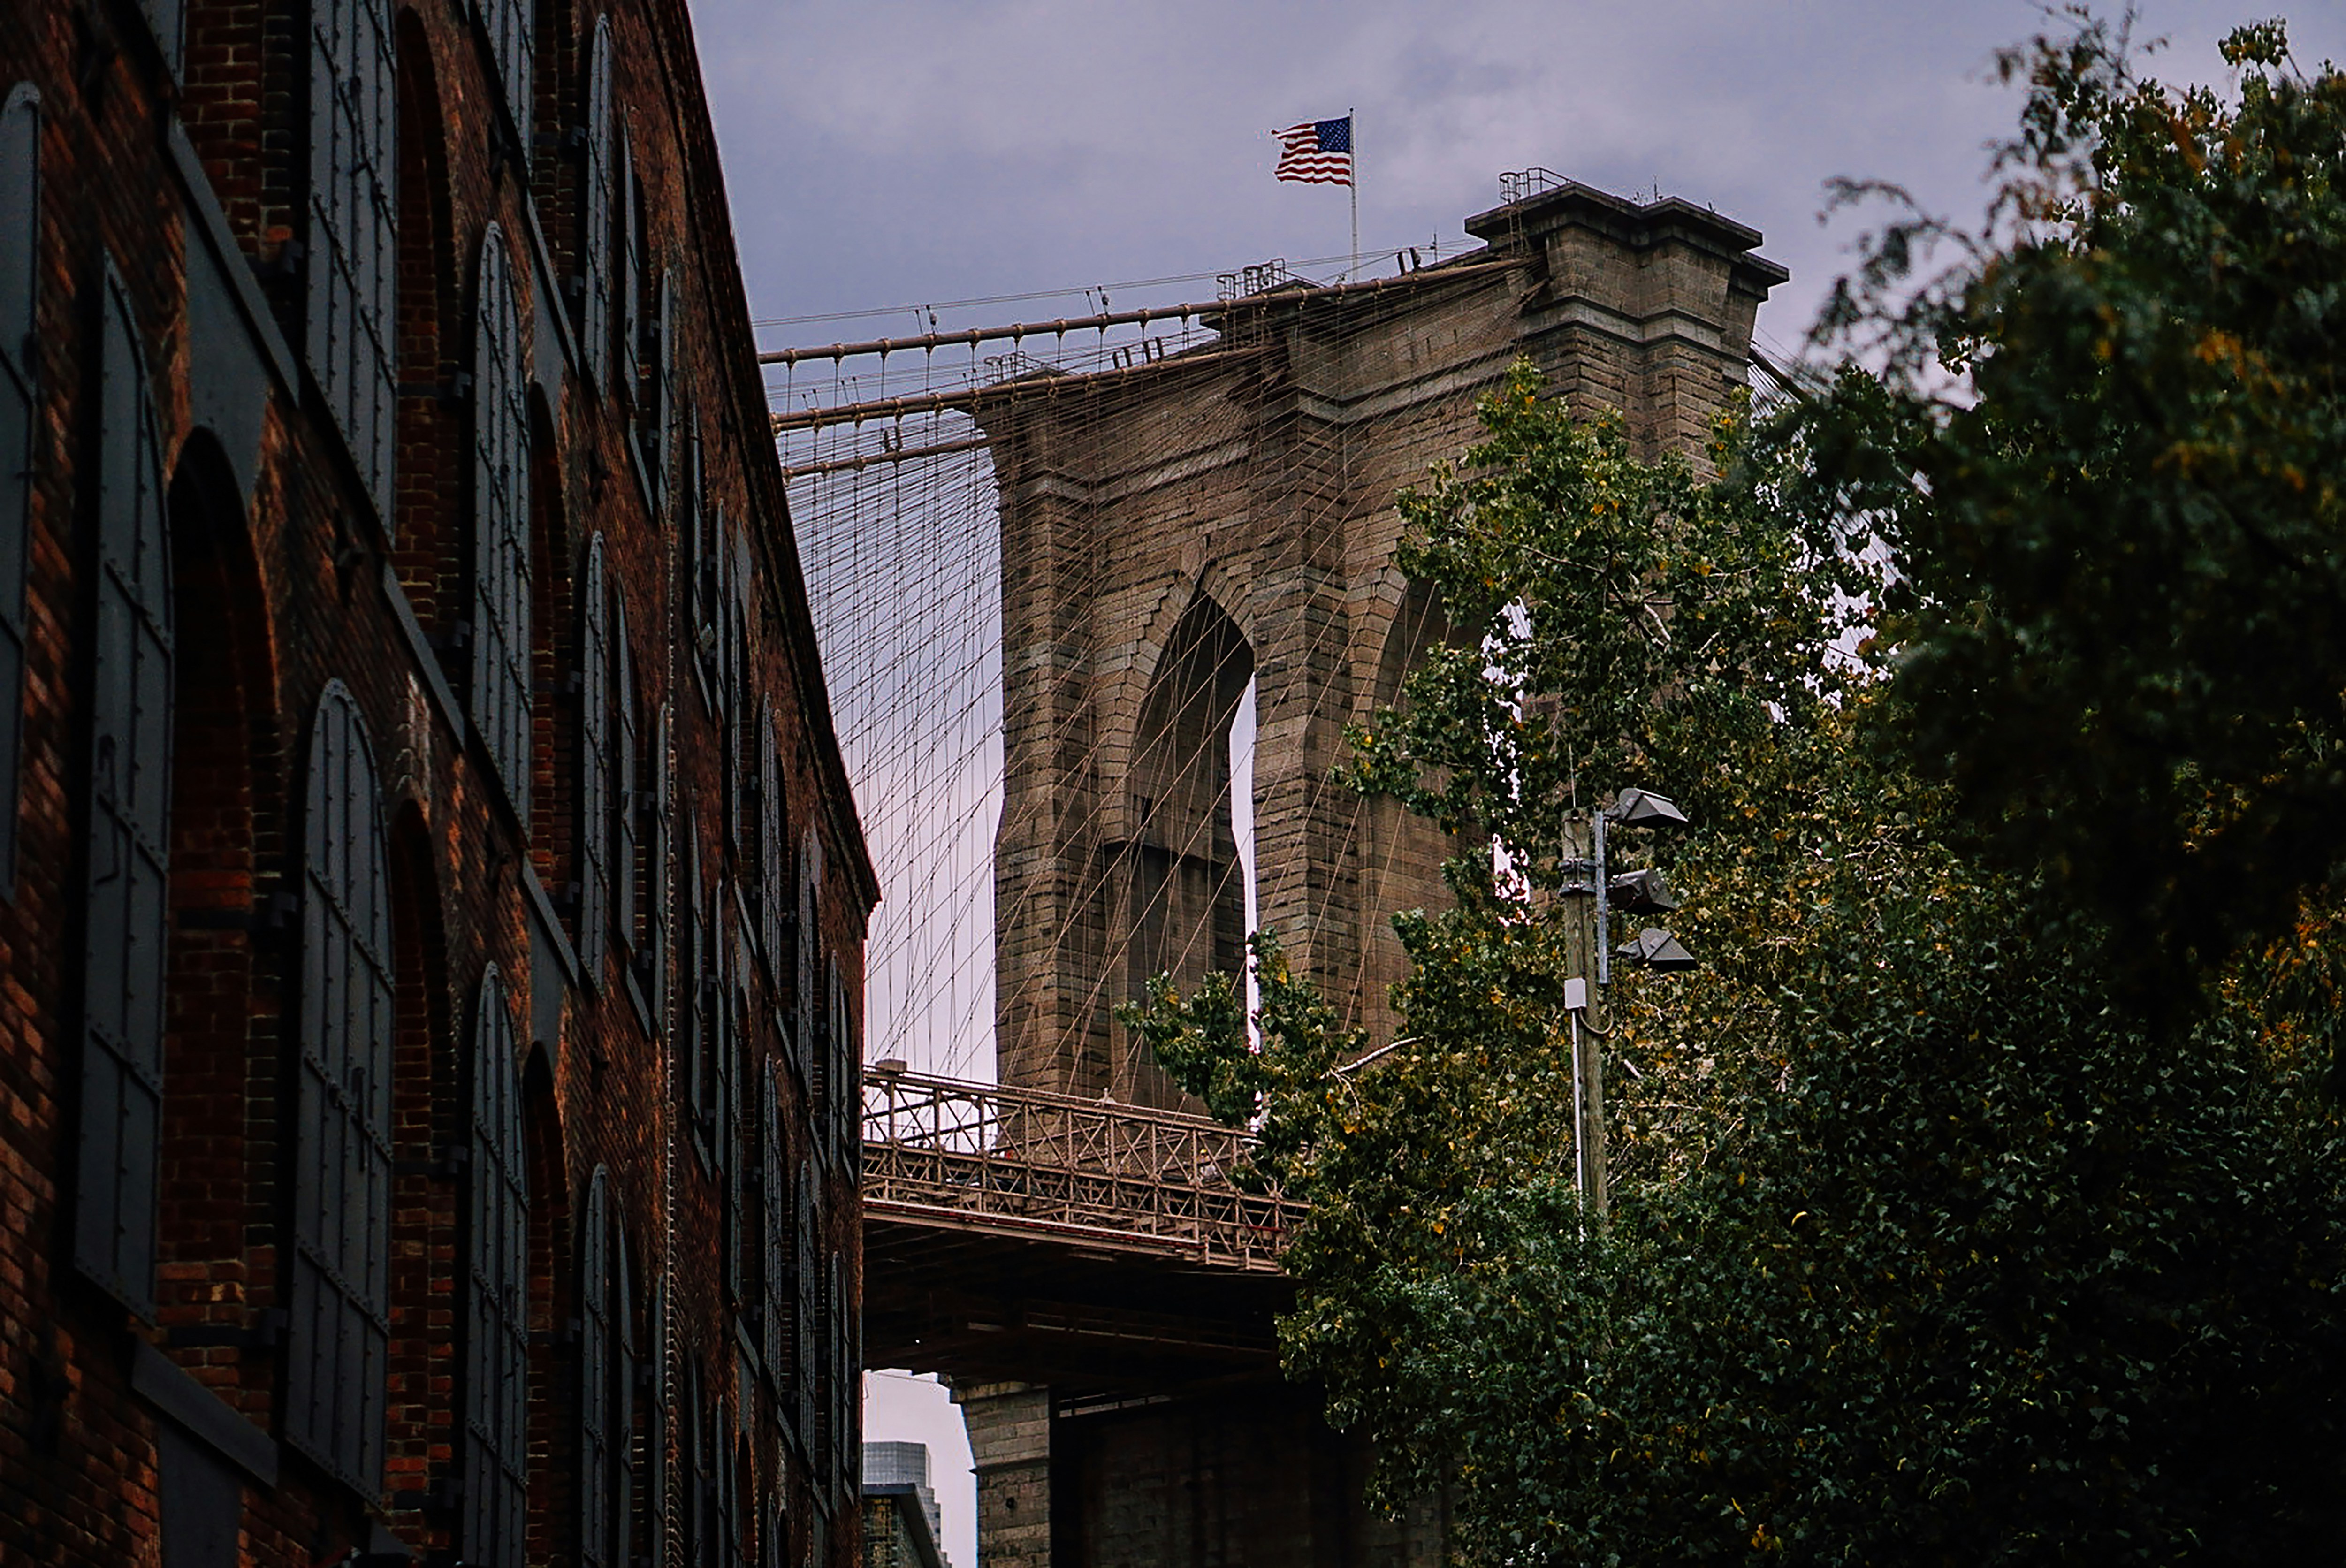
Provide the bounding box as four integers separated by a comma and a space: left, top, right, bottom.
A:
934, 183, 1785, 1568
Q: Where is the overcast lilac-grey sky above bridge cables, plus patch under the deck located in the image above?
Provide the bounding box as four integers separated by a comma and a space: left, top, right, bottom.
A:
694, 0, 2346, 1568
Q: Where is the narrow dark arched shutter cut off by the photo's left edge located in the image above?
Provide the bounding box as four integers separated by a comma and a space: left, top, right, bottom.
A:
0, 82, 40, 887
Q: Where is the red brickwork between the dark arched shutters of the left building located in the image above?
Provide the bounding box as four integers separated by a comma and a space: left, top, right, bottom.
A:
0, 0, 875, 1566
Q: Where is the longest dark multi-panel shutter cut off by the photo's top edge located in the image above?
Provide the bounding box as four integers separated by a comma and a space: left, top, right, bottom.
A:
303, 0, 399, 531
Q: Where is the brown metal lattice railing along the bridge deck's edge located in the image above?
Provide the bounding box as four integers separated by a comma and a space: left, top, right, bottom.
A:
863, 1068, 1300, 1270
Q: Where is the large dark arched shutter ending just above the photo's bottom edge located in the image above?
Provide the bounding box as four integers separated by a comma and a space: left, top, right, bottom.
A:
286, 681, 392, 1495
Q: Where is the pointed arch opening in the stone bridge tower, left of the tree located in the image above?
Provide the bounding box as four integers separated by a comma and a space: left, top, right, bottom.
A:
1107, 594, 1255, 1105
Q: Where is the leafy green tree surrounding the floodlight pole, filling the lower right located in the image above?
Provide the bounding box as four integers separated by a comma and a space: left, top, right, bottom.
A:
1133, 371, 2346, 1563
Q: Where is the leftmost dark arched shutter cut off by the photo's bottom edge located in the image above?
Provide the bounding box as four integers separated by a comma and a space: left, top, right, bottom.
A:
462, 967, 530, 1568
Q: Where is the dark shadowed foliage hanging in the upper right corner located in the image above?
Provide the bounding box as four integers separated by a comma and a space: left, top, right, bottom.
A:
1806, 19, 2346, 986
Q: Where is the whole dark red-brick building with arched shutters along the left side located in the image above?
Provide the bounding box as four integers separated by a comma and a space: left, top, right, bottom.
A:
0, 0, 877, 1568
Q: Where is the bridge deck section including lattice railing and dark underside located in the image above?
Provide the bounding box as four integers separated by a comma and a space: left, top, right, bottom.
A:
863, 1063, 1300, 1397
